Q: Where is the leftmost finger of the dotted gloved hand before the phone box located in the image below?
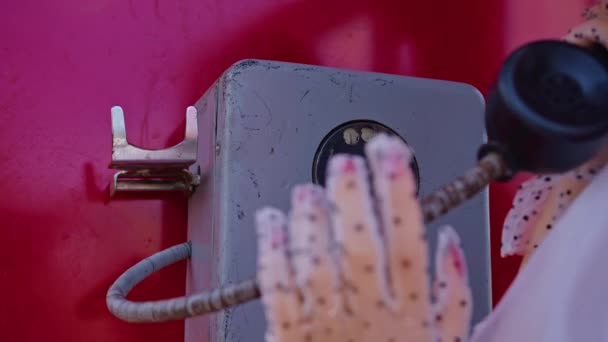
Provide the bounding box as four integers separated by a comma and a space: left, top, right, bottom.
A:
256, 208, 301, 342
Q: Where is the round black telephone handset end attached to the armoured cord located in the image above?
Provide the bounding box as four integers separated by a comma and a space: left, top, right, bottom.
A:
479, 40, 608, 180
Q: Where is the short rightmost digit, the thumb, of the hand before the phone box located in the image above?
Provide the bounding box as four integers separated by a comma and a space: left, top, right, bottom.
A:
434, 226, 473, 342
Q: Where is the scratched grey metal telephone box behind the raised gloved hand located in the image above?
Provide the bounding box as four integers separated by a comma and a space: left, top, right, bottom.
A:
186, 60, 491, 342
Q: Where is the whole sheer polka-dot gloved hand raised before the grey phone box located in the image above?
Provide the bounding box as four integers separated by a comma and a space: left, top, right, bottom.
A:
256, 135, 472, 342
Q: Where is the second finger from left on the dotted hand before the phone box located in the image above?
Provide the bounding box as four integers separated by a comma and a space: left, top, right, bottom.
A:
289, 185, 342, 342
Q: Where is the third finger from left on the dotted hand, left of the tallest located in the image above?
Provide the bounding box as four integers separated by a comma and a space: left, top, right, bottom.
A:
327, 155, 390, 326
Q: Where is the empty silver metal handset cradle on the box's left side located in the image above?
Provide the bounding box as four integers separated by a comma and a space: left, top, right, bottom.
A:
110, 106, 200, 196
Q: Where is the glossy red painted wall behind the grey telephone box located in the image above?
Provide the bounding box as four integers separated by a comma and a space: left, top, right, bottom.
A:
0, 0, 583, 342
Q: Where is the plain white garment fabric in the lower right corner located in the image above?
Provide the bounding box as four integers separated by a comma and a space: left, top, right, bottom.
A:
472, 161, 608, 342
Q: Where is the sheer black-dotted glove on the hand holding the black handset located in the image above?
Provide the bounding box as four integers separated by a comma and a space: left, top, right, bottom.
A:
501, 0, 608, 265
